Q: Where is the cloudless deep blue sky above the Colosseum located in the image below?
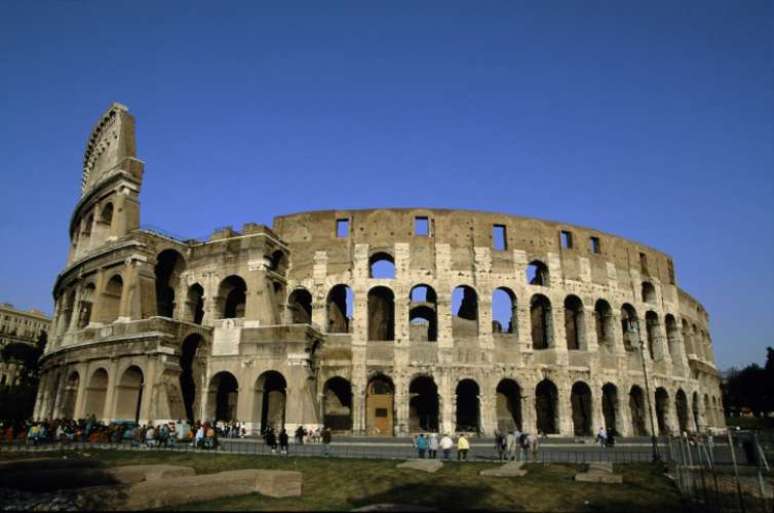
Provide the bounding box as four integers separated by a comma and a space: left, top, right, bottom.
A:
0, 0, 774, 368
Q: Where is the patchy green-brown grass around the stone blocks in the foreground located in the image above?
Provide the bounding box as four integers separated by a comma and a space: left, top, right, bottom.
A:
0, 450, 683, 512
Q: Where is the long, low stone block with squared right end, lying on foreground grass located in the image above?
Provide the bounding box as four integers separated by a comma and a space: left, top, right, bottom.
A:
114, 469, 302, 510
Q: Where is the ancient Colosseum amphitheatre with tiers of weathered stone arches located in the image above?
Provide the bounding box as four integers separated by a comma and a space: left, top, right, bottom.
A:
35, 104, 724, 436
